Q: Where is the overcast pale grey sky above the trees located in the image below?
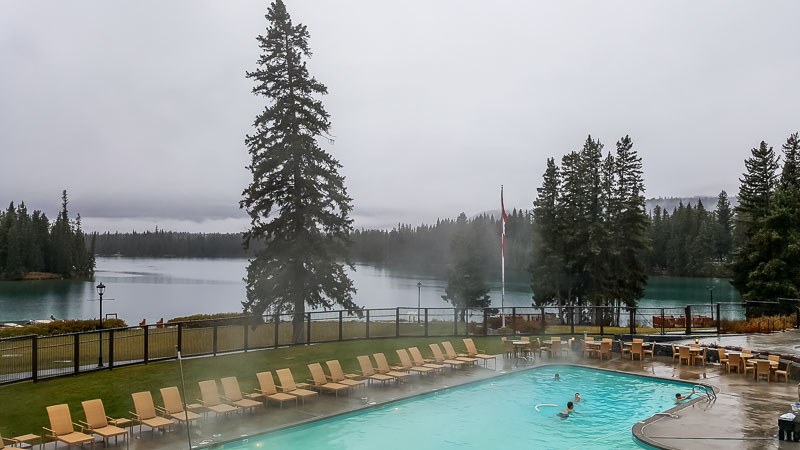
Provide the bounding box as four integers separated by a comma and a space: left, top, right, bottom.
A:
0, 0, 800, 231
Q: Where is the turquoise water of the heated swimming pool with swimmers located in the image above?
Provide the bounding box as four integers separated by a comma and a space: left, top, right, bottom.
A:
223, 366, 691, 450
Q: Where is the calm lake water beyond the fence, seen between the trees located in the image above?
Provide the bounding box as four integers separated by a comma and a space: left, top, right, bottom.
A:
0, 257, 740, 325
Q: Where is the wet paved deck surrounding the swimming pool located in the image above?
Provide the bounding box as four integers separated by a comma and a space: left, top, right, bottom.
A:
51, 335, 800, 450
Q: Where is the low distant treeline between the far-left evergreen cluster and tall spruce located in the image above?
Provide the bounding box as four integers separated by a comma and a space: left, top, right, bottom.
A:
95, 228, 252, 258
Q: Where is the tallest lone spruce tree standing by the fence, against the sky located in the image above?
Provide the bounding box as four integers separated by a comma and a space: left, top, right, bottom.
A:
240, 0, 360, 343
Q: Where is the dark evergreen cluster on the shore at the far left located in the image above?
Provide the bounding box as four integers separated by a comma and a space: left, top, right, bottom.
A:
0, 191, 94, 280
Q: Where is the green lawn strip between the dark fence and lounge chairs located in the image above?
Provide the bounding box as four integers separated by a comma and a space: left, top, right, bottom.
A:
0, 336, 502, 436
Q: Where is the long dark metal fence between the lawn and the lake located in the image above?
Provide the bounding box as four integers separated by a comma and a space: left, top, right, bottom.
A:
0, 303, 788, 384
